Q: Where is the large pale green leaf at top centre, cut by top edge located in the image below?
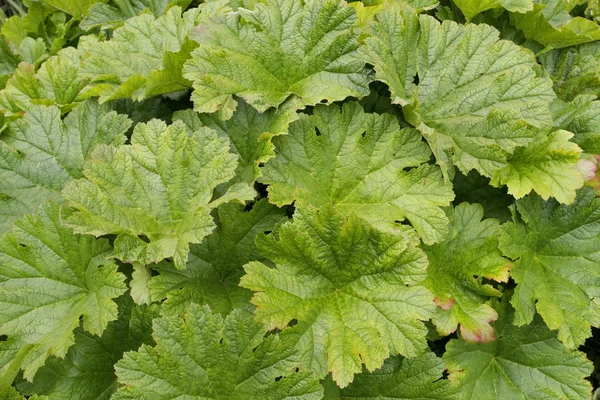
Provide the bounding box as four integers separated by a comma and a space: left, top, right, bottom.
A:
184, 0, 370, 119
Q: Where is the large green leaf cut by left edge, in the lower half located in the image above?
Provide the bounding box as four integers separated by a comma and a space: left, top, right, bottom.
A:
0, 204, 126, 387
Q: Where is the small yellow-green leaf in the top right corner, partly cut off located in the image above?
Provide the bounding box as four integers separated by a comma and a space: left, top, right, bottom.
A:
510, 0, 600, 48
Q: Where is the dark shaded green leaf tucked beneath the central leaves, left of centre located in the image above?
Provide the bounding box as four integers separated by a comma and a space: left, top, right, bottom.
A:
149, 199, 285, 315
